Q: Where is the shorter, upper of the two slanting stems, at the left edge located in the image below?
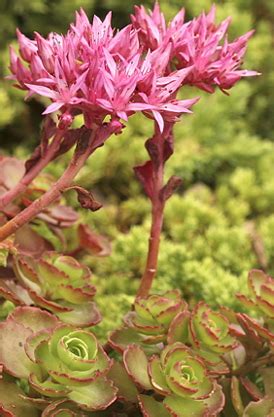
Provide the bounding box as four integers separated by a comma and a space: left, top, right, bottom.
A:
0, 129, 64, 210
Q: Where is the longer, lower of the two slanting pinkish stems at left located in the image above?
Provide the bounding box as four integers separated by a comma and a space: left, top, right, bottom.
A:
0, 122, 120, 242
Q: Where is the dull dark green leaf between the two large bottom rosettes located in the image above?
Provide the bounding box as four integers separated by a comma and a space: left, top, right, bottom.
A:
108, 361, 138, 403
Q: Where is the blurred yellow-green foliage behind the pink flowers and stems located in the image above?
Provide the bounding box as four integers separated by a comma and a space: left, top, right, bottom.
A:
0, 0, 274, 332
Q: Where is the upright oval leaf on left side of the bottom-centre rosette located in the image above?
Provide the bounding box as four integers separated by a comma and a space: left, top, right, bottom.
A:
123, 345, 152, 390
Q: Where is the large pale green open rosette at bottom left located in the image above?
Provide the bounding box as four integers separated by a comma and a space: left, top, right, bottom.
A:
25, 326, 117, 410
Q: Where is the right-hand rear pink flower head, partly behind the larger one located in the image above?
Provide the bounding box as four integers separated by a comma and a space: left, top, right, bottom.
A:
131, 3, 258, 93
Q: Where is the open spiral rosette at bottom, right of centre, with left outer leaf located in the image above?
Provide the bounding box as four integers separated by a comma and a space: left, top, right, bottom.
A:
124, 343, 224, 417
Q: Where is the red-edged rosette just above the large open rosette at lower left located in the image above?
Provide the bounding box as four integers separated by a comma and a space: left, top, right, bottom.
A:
4, 252, 101, 327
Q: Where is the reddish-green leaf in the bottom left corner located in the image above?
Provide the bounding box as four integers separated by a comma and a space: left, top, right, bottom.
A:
0, 379, 40, 417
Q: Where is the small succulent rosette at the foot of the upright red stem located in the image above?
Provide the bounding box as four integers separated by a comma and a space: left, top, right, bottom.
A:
110, 290, 187, 351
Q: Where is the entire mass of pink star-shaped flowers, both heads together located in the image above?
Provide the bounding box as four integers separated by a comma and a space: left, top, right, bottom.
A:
10, 4, 257, 131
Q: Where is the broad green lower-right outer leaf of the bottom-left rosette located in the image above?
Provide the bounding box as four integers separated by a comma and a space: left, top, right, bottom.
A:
68, 378, 117, 410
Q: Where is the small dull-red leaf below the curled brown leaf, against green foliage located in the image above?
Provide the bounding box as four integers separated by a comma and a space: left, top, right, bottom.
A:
78, 224, 111, 256
